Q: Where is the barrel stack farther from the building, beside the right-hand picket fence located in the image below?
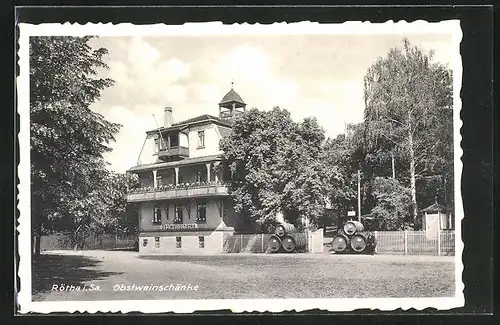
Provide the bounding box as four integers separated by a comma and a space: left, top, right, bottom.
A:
332, 220, 377, 254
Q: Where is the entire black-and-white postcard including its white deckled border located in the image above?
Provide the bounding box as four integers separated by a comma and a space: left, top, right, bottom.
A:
17, 20, 464, 313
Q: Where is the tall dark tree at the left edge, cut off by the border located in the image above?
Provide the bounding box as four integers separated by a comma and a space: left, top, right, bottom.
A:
29, 37, 120, 255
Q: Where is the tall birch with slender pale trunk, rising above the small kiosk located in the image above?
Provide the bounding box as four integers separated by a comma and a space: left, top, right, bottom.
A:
364, 40, 453, 220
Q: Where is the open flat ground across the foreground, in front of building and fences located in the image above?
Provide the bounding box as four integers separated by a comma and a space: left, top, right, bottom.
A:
33, 251, 455, 300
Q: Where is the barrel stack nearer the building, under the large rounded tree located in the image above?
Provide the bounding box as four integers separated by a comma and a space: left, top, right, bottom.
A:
268, 222, 307, 253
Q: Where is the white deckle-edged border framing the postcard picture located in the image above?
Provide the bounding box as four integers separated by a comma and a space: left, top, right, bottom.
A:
17, 20, 464, 313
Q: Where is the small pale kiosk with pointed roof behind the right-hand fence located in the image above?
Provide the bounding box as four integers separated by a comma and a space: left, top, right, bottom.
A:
420, 201, 453, 239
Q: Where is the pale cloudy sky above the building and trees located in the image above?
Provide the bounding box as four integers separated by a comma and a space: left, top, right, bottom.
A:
91, 34, 453, 172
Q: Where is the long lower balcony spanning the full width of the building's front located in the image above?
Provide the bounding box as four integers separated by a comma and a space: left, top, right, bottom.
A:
127, 182, 228, 202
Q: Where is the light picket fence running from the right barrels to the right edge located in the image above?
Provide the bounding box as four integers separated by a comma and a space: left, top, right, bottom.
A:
374, 230, 455, 255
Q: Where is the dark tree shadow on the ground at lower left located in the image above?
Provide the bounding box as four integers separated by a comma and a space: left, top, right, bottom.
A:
32, 254, 123, 301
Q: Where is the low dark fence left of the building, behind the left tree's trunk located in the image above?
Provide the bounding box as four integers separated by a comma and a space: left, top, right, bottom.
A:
40, 234, 138, 251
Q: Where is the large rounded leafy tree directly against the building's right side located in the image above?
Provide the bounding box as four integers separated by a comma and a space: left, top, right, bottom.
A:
220, 107, 325, 226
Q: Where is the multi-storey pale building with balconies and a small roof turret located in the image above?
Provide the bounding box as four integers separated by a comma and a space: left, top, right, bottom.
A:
127, 89, 246, 254
